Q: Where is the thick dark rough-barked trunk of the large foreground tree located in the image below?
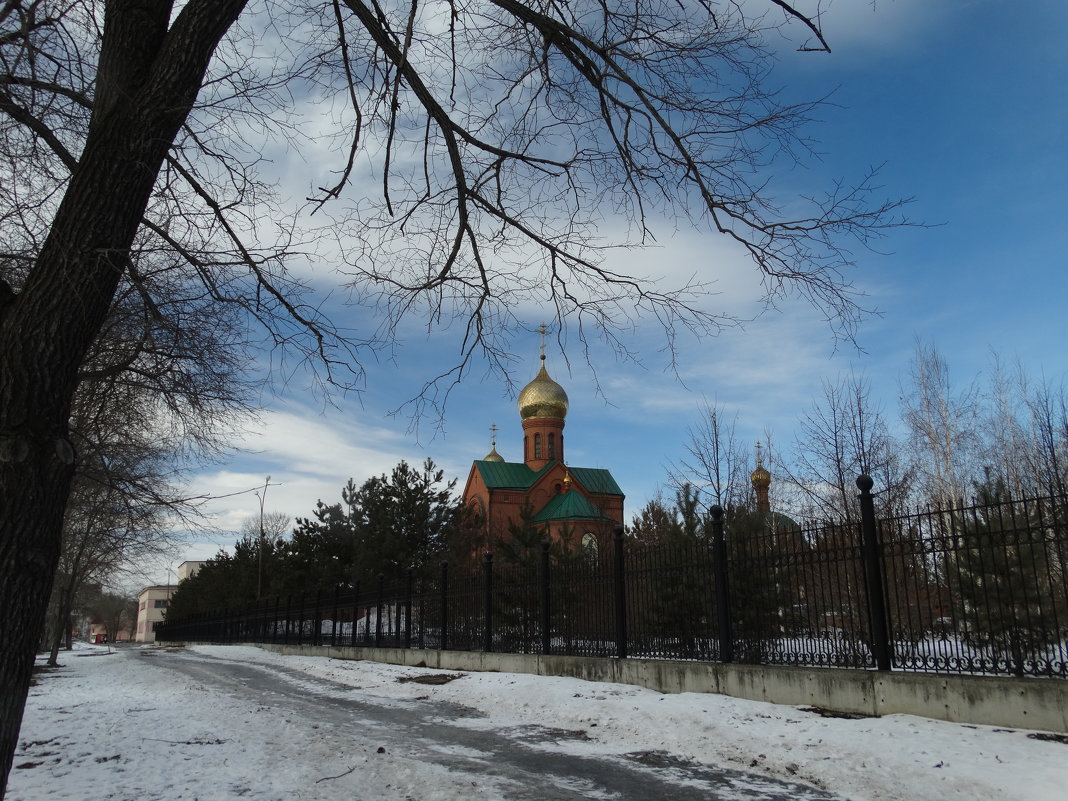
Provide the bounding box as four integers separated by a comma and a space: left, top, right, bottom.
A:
0, 0, 247, 797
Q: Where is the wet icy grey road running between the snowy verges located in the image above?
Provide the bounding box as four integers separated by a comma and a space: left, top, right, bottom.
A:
144, 650, 842, 801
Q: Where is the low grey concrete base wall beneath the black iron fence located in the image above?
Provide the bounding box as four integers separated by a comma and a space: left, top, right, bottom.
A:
194, 643, 1068, 732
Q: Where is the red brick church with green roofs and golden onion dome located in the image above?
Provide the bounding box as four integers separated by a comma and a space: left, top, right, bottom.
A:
464, 352, 624, 554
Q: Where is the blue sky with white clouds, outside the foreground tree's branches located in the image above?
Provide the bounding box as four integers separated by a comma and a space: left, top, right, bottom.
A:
134, 0, 1068, 583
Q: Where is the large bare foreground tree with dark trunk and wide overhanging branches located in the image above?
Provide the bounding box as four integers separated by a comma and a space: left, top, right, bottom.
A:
0, 0, 899, 781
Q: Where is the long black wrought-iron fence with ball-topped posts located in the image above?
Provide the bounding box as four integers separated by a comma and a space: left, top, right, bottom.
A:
157, 476, 1068, 678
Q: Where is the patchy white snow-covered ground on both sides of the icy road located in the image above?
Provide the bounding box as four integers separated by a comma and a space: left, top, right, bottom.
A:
7, 645, 1068, 801
